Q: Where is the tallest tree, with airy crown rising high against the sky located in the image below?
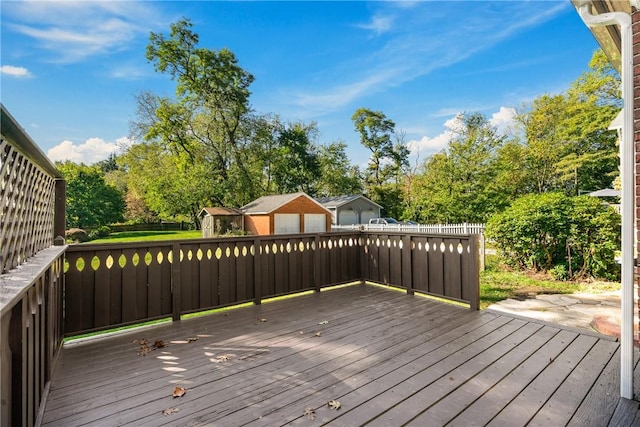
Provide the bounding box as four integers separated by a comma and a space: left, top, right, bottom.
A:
132, 19, 253, 207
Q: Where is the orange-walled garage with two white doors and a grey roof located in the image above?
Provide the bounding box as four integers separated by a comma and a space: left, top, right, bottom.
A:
240, 192, 331, 235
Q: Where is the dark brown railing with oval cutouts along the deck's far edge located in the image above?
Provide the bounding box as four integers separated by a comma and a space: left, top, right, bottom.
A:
65, 232, 478, 336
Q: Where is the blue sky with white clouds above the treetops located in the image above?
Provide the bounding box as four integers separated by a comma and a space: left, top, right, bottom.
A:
0, 0, 598, 165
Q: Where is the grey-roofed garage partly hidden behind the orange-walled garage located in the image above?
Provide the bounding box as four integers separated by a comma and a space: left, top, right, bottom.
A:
316, 194, 382, 225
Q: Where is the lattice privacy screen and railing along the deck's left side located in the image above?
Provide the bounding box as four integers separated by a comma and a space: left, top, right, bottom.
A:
0, 106, 65, 426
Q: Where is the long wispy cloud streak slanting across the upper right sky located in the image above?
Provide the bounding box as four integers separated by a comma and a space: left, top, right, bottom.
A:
282, 2, 570, 114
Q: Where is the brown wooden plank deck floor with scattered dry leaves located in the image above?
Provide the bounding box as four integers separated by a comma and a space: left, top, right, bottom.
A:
43, 285, 640, 427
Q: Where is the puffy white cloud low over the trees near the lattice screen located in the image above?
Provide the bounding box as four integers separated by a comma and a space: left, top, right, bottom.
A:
47, 137, 122, 165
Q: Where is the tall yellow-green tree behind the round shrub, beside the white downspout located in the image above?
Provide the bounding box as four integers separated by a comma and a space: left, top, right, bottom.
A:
519, 50, 621, 195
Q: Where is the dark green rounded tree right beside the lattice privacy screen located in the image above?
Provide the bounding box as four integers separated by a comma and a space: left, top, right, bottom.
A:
56, 161, 124, 228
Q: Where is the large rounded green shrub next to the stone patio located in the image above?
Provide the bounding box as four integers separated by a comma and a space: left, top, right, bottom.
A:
486, 193, 620, 280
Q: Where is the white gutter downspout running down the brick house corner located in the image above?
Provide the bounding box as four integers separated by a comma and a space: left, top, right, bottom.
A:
576, 0, 635, 399
